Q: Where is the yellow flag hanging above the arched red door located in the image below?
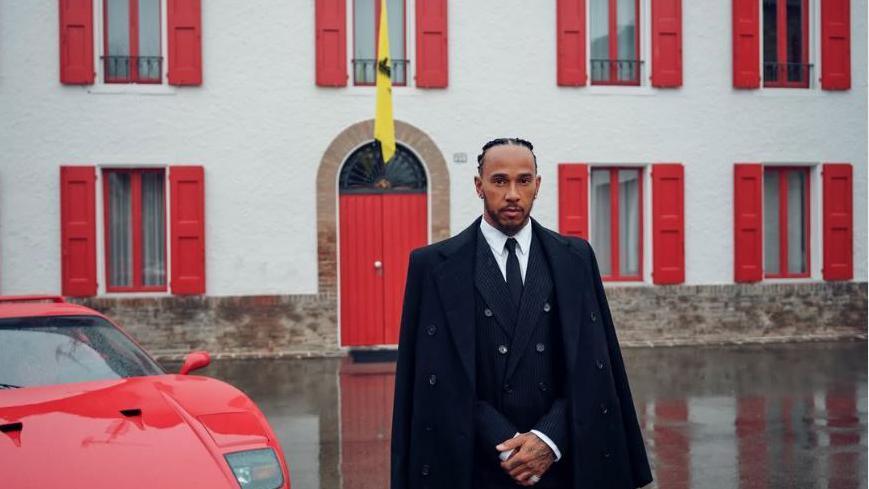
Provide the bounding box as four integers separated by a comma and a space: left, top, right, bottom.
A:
374, 0, 395, 163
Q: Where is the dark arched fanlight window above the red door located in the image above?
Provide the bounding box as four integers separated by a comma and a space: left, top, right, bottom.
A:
338, 141, 428, 194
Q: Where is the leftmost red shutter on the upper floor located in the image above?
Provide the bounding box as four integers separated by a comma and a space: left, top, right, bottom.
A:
60, 0, 94, 85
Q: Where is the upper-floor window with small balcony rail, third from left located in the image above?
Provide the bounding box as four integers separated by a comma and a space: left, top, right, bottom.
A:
589, 0, 642, 85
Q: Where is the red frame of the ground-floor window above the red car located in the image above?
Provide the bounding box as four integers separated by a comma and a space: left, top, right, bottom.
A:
102, 168, 169, 292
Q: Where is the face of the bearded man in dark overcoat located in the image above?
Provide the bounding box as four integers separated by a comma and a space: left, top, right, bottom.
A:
474, 144, 540, 236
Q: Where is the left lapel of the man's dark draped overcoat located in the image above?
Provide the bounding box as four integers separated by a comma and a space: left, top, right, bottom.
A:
434, 219, 480, 388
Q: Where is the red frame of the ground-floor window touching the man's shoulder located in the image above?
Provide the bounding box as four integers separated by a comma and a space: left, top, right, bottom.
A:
588, 165, 646, 282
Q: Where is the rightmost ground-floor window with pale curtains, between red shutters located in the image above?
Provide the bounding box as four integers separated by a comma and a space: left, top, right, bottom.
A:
763, 167, 810, 278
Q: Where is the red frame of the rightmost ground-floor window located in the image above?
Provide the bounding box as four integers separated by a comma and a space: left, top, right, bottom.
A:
761, 165, 812, 279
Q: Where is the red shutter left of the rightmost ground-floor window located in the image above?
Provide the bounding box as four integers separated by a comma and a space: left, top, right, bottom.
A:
733, 163, 763, 282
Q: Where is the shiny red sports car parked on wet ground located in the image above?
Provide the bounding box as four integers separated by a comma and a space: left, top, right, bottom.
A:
0, 296, 290, 489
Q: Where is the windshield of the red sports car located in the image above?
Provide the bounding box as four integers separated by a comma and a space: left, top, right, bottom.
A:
0, 316, 165, 389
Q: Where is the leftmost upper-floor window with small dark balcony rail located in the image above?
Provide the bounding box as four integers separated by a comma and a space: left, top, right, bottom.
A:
102, 0, 163, 83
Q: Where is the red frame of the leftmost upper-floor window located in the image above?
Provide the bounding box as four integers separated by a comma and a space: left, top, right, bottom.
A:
100, 0, 166, 85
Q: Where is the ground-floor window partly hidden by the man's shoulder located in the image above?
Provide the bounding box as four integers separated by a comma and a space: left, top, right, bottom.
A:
590, 168, 643, 280
